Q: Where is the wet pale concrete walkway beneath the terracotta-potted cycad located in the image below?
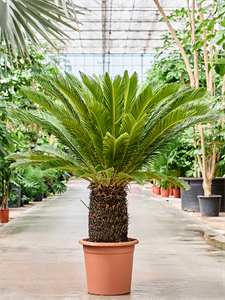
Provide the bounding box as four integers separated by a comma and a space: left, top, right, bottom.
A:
0, 179, 225, 300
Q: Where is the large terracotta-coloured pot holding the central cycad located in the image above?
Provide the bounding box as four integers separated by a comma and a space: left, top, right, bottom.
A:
79, 238, 139, 295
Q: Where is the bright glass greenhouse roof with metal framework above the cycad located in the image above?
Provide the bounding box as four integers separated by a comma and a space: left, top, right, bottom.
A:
59, 0, 187, 55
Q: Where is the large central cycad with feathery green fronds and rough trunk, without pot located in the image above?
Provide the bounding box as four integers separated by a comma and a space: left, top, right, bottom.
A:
10, 71, 218, 242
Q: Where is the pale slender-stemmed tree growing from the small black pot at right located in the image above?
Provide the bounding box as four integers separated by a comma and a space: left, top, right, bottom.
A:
154, 0, 225, 196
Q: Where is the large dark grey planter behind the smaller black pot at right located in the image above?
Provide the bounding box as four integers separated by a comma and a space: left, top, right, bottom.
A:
180, 177, 225, 212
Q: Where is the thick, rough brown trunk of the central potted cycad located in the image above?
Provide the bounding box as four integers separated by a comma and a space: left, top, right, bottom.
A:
89, 183, 129, 243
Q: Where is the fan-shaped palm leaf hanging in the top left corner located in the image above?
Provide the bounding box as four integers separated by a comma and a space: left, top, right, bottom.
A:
0, 0, 85, 58
